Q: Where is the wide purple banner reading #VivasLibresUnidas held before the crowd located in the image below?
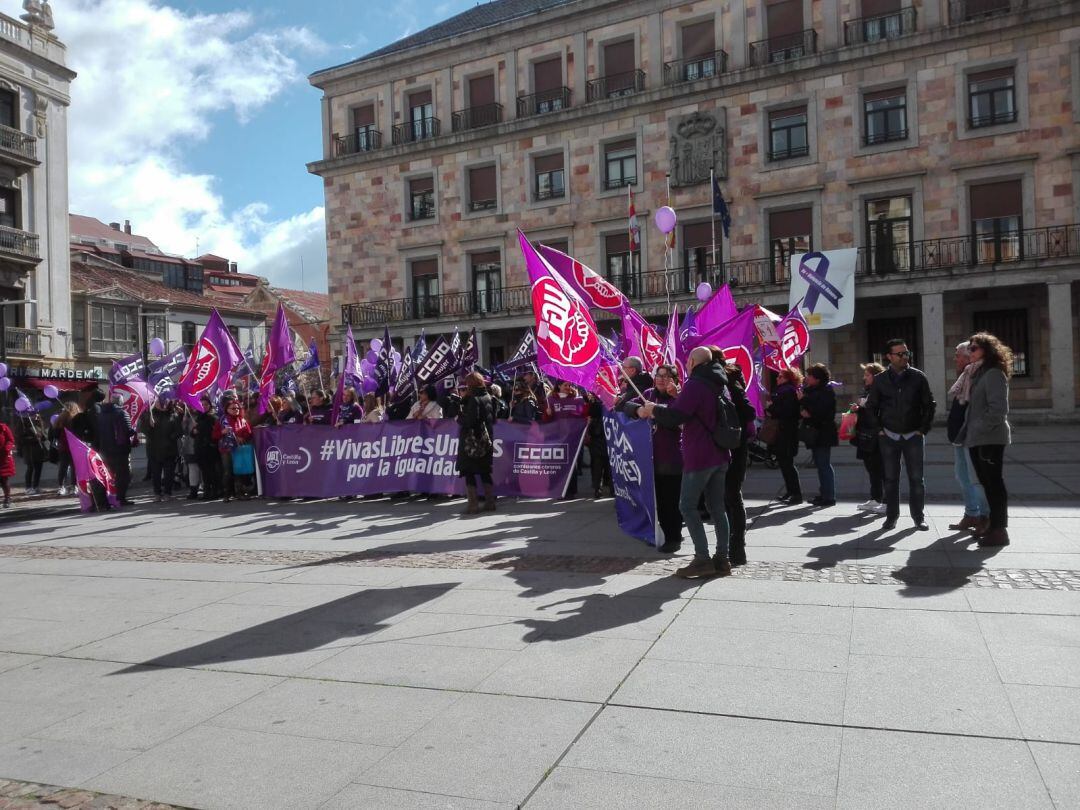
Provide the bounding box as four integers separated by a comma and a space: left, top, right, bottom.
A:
255, 419, 585, 498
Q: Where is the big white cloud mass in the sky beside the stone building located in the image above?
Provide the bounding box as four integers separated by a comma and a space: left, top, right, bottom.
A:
50, 0, 326, 289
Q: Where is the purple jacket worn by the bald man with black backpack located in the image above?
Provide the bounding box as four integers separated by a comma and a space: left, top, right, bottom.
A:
653, 363, 731, 472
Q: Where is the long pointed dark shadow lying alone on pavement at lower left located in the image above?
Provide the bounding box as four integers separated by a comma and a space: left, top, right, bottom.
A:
111, 582, 457, 675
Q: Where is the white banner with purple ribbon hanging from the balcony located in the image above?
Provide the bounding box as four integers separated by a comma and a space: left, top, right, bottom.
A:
788, 247, 859, 329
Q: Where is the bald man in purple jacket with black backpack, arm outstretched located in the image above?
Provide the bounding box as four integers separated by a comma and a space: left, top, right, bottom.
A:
637, 346, 743, 579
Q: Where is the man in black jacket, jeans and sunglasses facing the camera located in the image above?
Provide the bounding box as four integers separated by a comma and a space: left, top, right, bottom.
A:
866, 338, 937, 531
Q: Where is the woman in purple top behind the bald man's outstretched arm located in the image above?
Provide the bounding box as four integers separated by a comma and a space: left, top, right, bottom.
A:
623, 366, 683, 554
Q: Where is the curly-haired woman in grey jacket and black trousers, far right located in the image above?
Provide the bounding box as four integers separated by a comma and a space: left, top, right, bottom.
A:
959, 332, 1013, 548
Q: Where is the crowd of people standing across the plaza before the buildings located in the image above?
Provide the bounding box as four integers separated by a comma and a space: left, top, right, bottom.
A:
0, 334, 1012, 578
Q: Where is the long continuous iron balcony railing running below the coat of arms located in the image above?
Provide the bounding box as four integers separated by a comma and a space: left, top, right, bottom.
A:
341, 225, 1080, 326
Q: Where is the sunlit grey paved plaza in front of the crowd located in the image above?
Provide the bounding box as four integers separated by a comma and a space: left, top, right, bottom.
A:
0, 428, 1080, 810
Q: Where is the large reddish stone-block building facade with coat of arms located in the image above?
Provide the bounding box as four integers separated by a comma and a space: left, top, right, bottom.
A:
309, 0, 1080, 415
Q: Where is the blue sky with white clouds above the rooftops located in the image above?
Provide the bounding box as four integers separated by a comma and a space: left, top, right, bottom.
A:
0, 0, 474, 291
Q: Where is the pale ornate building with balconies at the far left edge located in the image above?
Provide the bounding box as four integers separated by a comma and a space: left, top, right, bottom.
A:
0, 11, 76, 367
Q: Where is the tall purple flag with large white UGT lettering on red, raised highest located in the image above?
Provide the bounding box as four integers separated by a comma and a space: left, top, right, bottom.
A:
517, 230, 606, 392
